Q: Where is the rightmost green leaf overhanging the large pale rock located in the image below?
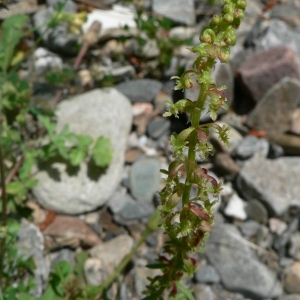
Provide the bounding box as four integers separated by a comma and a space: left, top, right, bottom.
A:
92, 136, 113, 167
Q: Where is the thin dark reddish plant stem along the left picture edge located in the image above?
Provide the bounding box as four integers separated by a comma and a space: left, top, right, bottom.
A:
0, 142, 7, 288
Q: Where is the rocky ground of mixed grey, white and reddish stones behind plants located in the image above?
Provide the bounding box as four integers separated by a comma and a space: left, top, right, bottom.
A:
1, 0, 300, 300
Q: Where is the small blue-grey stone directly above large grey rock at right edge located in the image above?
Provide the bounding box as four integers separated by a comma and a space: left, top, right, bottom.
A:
231, 135, 269, 160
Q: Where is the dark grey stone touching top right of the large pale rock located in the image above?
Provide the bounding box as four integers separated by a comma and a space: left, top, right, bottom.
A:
116, 78, 162, 103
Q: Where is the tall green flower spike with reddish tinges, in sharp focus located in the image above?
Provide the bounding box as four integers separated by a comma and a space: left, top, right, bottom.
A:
144, 0, 246, 299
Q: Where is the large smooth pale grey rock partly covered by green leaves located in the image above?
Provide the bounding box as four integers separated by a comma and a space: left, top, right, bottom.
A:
33, 89, 132, 214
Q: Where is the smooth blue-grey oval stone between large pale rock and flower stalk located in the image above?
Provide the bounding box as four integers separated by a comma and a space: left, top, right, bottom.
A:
129, 158, 160, 202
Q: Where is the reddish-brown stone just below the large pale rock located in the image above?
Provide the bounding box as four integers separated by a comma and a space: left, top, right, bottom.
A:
43, 215, 101, 250
